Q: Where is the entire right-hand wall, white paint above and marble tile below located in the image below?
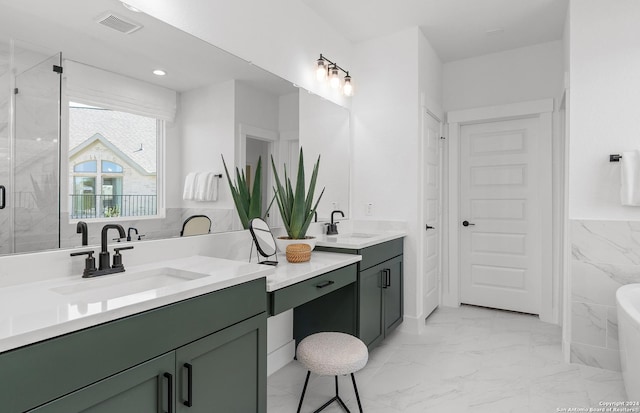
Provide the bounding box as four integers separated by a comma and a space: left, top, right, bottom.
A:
564, 0, 640, 369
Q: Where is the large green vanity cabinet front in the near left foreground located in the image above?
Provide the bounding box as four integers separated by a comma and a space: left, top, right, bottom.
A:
0, 278, 267, 413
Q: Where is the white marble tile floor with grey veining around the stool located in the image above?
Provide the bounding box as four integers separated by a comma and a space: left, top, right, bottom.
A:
267, 306, 626, 413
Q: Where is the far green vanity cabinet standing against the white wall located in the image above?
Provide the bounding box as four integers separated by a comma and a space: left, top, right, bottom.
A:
316, 238, 404, 349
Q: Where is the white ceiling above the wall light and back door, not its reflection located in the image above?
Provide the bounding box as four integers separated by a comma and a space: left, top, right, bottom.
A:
302, 0, 568, 62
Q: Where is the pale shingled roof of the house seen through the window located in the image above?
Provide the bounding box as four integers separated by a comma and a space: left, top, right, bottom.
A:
69, 107, 157, 173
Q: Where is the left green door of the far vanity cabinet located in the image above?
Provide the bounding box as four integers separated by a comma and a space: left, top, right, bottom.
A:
358, 265, 384, 346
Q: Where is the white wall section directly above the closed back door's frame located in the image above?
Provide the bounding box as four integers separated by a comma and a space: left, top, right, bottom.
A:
443, 41, 564, 111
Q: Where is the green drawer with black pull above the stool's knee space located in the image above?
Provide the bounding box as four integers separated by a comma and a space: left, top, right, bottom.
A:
269, 264, 357, 315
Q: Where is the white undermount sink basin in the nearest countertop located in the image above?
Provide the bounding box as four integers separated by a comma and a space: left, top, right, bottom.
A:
51, 267, 207, 300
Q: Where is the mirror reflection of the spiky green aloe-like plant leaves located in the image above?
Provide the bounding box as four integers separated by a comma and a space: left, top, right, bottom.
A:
222, 156, 273, 229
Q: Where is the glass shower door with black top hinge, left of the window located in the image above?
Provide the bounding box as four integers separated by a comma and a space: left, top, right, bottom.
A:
13, 53, 62, 252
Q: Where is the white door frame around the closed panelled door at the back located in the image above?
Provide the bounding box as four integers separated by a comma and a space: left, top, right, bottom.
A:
441, 99, 559, 324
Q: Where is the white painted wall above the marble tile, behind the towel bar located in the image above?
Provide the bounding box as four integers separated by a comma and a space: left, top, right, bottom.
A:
569, 0, 640, 220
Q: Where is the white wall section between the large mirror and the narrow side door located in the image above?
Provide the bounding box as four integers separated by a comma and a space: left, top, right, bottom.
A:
351, 28, 441, 329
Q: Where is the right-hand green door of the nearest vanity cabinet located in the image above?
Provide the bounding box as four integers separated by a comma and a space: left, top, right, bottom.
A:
176, 314, 267, 413
